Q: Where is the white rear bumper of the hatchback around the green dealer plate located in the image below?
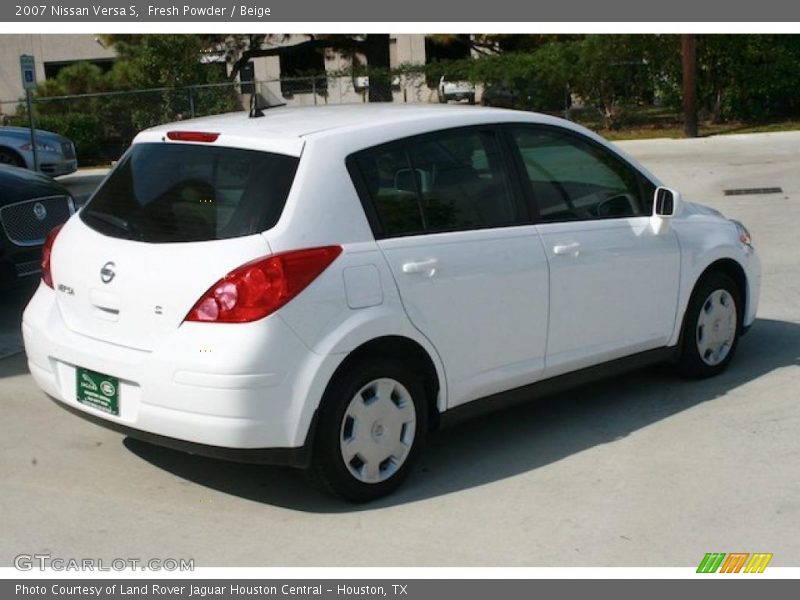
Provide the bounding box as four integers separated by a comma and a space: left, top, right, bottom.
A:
22, 285, 332, 458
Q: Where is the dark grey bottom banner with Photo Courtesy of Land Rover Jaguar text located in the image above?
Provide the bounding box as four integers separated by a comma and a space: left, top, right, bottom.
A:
0, 574, 798, 600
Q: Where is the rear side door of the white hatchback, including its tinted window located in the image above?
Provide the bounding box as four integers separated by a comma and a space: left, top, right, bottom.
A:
355, 127, 548, 407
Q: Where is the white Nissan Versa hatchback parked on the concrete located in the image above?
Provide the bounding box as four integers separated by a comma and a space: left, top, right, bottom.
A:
22, 105, 760, 500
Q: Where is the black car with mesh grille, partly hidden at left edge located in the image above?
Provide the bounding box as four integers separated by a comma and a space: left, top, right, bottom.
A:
0, 165, 75, 288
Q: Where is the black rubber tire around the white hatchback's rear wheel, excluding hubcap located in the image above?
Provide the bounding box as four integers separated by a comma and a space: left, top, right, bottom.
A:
308, 358, 428, 502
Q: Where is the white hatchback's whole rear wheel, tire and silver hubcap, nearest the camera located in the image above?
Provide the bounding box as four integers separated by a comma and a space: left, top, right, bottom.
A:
310, 358, 427, 502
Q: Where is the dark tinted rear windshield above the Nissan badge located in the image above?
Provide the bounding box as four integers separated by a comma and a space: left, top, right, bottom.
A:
81, 144, 299, 242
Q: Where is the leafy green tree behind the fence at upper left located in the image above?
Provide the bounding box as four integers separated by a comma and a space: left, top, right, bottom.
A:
26, 35, 241, 164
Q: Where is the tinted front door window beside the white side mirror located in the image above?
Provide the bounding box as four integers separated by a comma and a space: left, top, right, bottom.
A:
511, 127, 652, 222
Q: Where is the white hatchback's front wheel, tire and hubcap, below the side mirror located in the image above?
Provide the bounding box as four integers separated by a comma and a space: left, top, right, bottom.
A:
679, 272, 743, 378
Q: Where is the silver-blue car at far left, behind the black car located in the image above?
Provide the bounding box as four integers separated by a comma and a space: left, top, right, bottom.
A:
0, 127, 78, 177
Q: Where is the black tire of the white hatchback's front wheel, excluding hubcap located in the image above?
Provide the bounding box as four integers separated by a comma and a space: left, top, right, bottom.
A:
678, 271, 744, 379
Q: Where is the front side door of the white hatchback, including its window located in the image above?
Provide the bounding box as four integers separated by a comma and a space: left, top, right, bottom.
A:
507, 125, 680, 376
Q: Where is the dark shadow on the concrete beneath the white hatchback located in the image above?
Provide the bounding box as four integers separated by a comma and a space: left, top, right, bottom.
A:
124, 319, 800, 513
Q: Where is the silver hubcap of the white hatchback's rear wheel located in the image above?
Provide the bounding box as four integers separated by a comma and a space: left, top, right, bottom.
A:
339, 378, 417, 483
